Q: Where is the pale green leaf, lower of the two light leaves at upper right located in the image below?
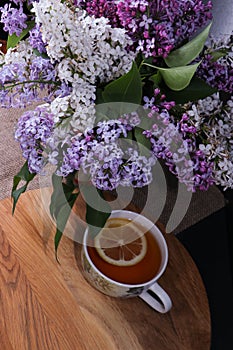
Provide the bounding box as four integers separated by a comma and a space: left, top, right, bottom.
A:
156, 62, 200, 91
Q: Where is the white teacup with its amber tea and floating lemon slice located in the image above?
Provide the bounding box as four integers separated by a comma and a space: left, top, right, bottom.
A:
81, 210, 172, 313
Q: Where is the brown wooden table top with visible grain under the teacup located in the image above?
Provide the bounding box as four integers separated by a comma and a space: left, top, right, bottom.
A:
0, 190, 211, 350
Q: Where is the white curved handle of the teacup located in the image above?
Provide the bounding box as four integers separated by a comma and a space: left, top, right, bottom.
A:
139, 282, 172, 314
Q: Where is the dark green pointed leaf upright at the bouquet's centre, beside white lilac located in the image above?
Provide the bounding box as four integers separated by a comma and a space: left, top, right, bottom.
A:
102, 62, 142, 104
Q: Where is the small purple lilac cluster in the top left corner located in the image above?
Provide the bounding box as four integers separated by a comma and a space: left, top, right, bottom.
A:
0, 3, 27, 36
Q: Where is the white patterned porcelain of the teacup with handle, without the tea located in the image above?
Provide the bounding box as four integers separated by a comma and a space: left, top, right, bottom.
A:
81, 210, 172, 313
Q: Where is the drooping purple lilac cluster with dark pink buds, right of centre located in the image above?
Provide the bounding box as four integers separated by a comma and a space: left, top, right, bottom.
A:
144, 89, 214, 191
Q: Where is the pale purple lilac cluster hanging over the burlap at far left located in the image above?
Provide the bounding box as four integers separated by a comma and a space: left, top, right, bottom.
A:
15, 106, 54, 173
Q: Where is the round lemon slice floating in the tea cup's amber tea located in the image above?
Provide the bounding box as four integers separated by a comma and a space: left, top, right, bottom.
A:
94, 218, 147, 266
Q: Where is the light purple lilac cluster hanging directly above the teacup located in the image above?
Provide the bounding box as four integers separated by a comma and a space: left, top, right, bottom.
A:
58, 120, 155, 190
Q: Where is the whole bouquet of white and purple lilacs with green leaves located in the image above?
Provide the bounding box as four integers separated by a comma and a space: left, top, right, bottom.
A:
0, 0, 233, 249
